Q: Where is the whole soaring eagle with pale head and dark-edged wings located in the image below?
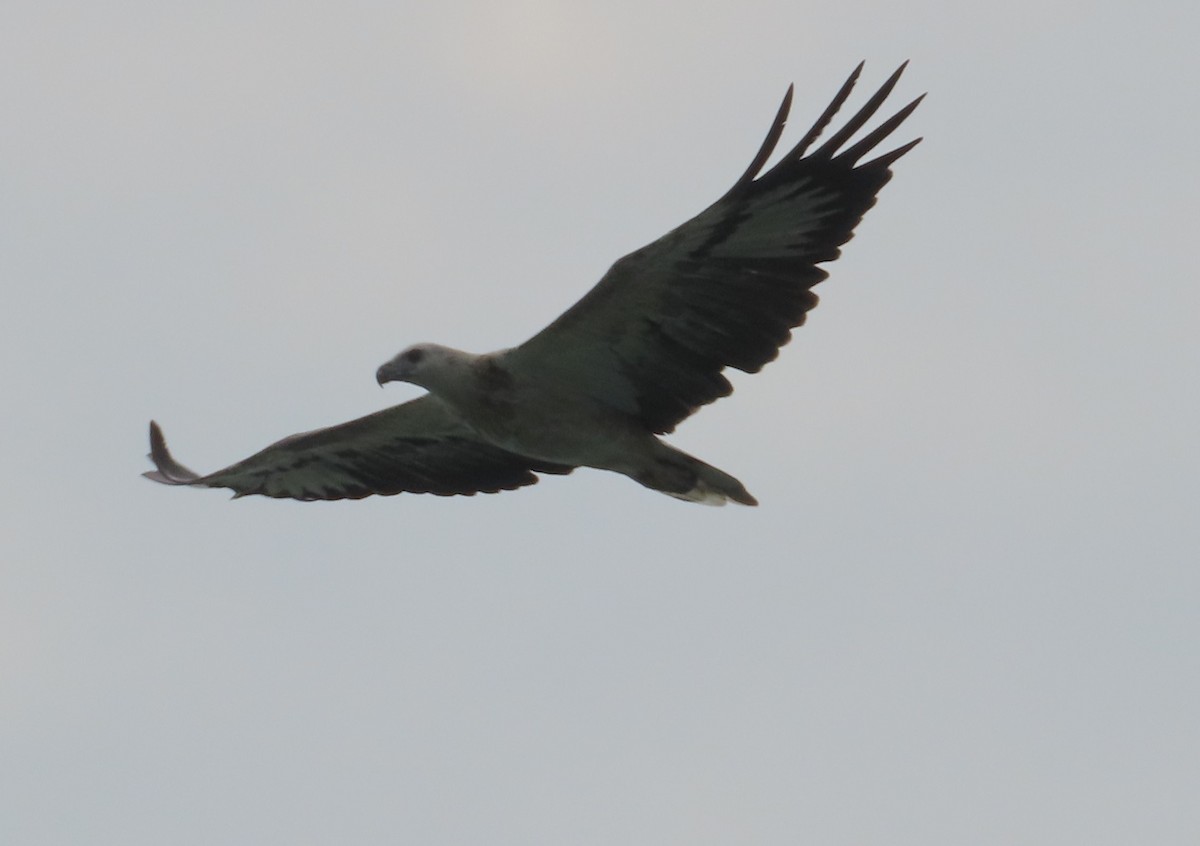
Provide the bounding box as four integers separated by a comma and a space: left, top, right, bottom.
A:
144, 62, 924, 505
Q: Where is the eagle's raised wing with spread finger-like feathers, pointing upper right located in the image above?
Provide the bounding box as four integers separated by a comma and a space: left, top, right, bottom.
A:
506, 65, 920, 433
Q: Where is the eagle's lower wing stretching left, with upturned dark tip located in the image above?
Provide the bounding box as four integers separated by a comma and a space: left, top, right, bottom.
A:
143, 395, 574, 500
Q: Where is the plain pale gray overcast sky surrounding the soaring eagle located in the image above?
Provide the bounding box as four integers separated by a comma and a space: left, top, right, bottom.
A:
0, 0, 1200, 846
